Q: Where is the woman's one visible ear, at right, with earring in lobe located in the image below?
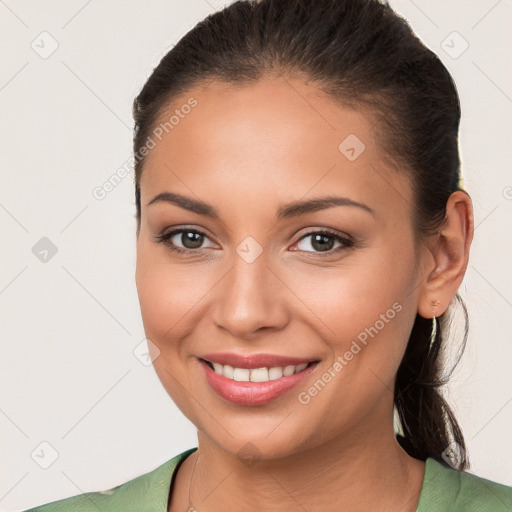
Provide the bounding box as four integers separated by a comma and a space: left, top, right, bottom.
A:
418, 190, 474, 318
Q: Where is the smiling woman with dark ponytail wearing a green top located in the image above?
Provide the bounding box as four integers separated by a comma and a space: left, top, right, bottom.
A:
25, 0, 512, 512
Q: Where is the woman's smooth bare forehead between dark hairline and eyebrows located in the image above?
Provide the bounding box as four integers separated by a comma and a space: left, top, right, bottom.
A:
141, 78, 411, 220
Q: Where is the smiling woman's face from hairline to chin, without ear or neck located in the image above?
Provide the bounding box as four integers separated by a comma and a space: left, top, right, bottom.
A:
136, 78, 422, 458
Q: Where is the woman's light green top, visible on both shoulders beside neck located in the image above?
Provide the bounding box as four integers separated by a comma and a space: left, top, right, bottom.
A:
25, 448, 512, 512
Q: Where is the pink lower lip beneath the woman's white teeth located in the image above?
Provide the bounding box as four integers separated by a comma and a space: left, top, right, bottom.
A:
199, 359, 318, 405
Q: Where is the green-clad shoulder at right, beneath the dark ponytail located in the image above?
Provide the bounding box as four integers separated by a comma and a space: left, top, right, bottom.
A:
417, 457, 512, 512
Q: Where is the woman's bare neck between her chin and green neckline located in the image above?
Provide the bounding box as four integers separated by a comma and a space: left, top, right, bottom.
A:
169, 427, 425, 512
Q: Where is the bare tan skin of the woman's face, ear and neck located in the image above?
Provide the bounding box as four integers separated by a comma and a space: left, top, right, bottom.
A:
136, 78, 473, 512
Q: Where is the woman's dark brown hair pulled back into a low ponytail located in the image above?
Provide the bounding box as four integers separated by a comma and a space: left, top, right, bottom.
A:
133, 0, 469, 470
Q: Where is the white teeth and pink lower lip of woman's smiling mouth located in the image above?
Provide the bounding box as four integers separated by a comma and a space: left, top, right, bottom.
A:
198, 358, 319, 406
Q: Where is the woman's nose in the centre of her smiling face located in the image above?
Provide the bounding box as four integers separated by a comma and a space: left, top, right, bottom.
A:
213, 254, 291, 340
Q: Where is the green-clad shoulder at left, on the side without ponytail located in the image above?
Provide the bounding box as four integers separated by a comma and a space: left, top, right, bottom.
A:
24, 448, 197, 512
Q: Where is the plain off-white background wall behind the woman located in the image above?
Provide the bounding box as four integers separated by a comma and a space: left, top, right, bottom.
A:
0, 0, 512, 511
